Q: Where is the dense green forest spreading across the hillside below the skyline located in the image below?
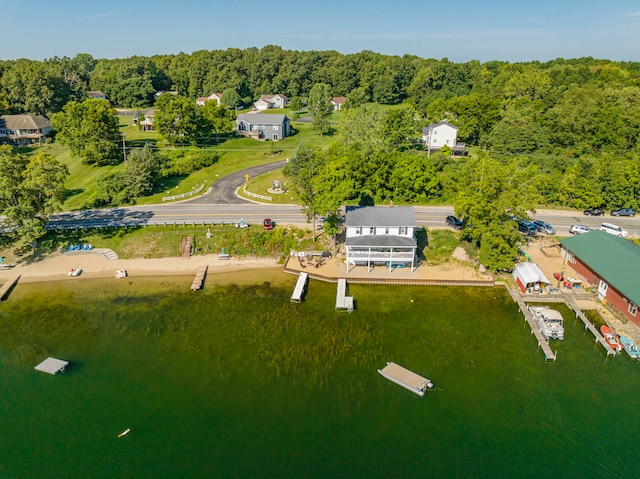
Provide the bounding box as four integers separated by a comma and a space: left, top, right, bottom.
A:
0, 46, 640, 267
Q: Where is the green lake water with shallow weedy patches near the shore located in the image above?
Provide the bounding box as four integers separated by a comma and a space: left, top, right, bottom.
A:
0, 271, 640, 478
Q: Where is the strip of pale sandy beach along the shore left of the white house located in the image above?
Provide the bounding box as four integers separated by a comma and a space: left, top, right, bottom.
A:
0, 253, 282, 283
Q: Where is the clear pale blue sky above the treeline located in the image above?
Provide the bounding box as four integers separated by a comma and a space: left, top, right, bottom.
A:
0, 0, 640, 62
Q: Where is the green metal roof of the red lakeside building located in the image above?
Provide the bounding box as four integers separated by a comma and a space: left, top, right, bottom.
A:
560, 231, 640, 304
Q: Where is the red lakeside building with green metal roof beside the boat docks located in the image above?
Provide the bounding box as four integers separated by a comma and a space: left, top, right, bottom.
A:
560, 231, 640, 326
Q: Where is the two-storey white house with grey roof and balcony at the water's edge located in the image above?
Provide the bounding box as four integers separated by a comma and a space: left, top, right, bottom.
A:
346, 206, 417, 272
